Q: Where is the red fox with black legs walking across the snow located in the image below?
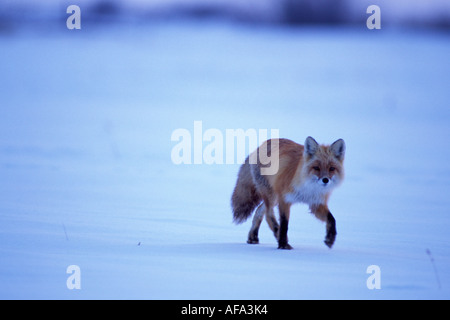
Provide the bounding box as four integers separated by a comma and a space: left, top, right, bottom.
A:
231, 137, 345, 249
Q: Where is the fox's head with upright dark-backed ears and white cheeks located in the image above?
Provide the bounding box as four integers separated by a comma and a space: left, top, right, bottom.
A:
303, 137, 345, 190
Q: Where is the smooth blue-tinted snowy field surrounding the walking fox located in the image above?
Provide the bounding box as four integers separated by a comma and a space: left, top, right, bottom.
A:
0, 22, 450, 299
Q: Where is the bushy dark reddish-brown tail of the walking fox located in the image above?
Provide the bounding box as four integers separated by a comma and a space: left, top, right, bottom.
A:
231, 158, 262, 223
